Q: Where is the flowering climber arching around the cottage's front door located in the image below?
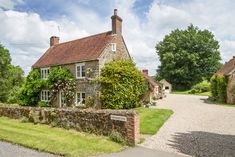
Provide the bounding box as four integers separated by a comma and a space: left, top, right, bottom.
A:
48, 67, 76, 106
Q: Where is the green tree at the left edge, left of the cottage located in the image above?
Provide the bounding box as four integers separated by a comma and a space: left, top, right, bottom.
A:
0, 45, 24, 103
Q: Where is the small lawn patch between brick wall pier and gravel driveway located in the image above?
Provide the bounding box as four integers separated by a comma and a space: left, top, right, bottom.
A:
136, 108, 173, 135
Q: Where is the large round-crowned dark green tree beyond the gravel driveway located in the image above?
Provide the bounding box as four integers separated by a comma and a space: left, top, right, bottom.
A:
156, 25, 221, 89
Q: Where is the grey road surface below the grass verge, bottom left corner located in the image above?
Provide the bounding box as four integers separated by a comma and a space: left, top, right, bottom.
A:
0, 141, 58, 157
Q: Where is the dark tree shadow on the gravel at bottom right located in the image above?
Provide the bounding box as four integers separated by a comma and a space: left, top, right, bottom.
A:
169, 131, 235, 157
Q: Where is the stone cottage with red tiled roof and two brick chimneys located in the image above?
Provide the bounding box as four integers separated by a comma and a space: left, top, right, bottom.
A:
32, 9, 131, 107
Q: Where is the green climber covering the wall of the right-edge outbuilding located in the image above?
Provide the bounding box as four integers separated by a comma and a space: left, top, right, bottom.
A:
211, 75, 228, 103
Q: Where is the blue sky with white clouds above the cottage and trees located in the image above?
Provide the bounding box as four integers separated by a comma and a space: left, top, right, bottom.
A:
0, 0, 235, 75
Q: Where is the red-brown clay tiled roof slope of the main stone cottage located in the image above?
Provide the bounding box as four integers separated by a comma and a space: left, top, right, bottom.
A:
32, 31, 113, 68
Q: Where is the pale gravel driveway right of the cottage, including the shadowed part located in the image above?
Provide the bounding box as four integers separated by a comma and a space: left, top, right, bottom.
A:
142, 94, 235, 157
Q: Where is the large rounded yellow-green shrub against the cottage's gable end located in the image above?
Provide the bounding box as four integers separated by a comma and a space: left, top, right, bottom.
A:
99, 60, 146, 109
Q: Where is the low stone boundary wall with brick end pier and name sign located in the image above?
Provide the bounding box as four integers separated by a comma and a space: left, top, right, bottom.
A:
0, 106, 140, 144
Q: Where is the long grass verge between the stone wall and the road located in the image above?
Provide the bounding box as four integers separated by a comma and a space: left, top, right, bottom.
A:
0, 117, 123, 157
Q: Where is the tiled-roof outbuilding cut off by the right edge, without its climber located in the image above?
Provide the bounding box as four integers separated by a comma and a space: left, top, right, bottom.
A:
215, 56, 235, 104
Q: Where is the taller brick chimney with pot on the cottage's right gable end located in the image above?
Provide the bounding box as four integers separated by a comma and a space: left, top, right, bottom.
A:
111, 9, 122, 34
